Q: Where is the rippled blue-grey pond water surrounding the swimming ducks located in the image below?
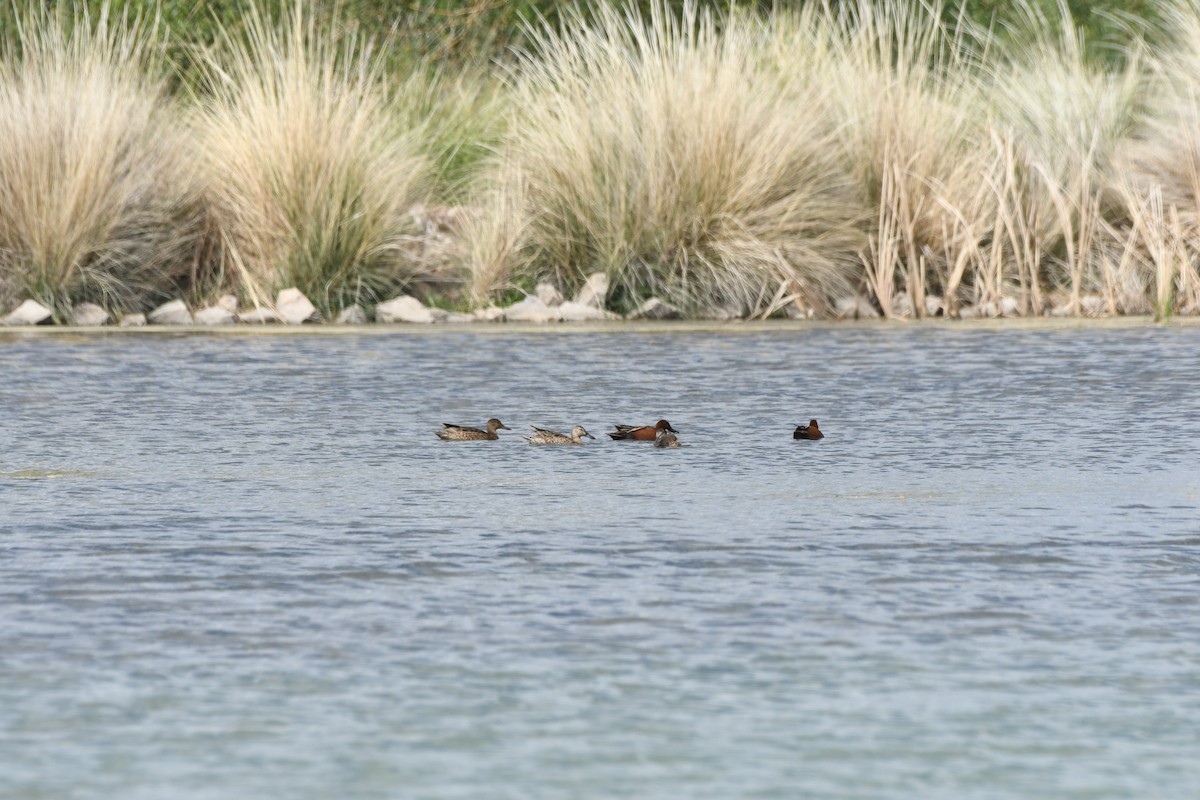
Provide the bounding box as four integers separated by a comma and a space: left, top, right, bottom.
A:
0, 326, 1200, 800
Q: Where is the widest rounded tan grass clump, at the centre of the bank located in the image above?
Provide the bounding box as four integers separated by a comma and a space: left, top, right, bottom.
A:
472, 5, 865, 315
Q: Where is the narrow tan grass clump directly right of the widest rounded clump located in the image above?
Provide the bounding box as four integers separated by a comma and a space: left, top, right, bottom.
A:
780, 0, 991, 317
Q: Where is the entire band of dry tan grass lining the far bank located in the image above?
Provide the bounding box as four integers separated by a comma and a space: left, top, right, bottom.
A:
7, 0, 1200, 318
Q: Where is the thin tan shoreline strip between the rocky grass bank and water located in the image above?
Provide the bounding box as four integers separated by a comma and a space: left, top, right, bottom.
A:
0, 315, 1200, 342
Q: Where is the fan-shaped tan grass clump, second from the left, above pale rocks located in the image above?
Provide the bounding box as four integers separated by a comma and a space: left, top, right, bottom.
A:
197, 2, 438, 312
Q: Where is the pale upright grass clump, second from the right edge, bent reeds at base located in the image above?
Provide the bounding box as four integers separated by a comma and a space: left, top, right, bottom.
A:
992, 2, 1142, 314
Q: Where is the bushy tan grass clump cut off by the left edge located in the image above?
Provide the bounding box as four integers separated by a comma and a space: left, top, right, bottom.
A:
0, 4, 208, 318
